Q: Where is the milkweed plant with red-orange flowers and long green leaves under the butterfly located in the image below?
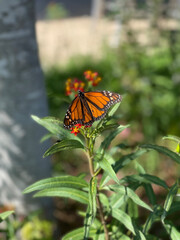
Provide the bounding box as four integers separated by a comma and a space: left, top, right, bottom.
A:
24, 71, 180, 240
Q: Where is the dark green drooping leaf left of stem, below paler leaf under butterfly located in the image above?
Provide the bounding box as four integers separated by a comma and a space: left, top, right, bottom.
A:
43, 139, 84, 157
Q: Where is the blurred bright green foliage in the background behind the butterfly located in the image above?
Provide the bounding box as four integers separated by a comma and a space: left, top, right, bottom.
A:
45, 34, 180, 141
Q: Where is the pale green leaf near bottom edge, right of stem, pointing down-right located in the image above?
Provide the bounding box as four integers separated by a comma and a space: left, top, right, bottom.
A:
112, 208, 135, 234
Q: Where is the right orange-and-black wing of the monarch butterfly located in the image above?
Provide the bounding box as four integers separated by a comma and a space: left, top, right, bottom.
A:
84, 91, 122, 124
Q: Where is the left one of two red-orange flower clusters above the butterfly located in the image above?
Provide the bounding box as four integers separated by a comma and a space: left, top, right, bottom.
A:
66, 78, 85, 96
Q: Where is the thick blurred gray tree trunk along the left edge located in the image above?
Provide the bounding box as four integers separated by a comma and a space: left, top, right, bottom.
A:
0, 0, 50, 214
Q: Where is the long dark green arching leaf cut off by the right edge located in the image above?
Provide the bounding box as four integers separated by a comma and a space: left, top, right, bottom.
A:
140, 144, 180, 163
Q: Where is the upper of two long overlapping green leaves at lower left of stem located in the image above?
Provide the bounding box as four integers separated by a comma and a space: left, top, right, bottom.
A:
23, 176, 88, 193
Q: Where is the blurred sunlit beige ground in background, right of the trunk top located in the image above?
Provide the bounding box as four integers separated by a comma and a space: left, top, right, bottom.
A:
36, 17, 177, 67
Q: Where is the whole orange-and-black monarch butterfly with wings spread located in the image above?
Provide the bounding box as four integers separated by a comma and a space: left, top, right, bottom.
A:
64, 90, 122, 129
